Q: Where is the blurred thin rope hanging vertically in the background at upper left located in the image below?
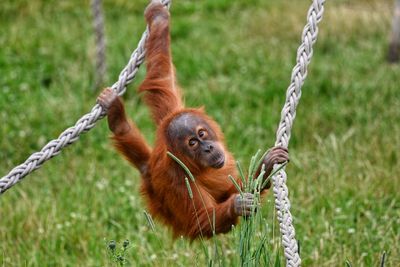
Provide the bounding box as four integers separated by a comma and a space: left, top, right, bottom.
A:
91, 0, 107, 90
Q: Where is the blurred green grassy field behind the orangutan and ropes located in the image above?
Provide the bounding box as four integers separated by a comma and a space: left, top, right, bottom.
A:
0, 0, 400, 266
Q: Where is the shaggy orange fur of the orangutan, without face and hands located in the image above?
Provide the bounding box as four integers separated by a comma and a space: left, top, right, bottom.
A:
108, 5, 242, 239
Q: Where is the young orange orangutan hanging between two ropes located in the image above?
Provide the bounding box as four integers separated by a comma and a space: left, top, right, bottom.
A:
98, 1, 288, 239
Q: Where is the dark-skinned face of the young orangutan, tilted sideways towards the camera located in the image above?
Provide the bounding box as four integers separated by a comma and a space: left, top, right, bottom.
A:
167, 113, 225, 169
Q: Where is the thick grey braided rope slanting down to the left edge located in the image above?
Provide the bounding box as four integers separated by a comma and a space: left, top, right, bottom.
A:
0, 0, 170, 195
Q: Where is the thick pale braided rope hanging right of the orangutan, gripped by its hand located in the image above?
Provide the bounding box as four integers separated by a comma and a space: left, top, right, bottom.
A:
272, 0, 325, 266
